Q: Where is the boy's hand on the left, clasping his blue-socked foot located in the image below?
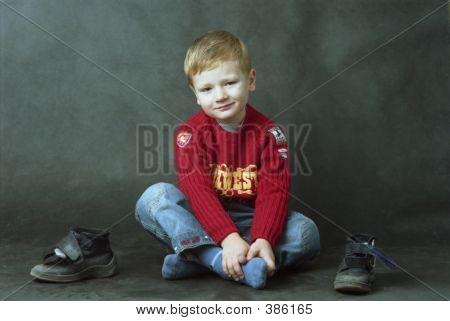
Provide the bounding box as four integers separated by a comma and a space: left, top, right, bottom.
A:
220, 232, 250, 281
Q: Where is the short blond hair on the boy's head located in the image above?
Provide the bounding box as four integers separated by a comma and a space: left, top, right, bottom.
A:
184, 30, 251, 87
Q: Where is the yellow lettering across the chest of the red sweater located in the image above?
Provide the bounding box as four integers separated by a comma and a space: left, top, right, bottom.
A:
209, 164, 258, 197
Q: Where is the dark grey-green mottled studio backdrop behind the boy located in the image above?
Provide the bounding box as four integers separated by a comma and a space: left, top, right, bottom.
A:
0, 0, 450, 243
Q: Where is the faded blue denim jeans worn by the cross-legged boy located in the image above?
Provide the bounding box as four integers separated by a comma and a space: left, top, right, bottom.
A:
135, 183, 320, 270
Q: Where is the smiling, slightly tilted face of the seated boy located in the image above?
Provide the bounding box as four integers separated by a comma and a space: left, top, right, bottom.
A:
192, 61, 256, 123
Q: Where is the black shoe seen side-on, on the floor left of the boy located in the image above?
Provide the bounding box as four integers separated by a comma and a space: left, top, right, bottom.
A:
30, 227, 117, 282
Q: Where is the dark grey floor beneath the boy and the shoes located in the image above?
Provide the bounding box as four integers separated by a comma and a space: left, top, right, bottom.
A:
0, 222, 450, 301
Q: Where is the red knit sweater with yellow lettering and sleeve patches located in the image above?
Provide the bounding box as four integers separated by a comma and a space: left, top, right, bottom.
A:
174, 104, 290, 248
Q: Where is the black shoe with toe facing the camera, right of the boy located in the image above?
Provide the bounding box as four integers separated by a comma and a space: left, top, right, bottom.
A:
334, 234, 375, 293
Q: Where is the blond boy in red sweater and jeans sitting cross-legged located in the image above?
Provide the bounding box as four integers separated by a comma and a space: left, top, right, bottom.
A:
136, 31, 320, 289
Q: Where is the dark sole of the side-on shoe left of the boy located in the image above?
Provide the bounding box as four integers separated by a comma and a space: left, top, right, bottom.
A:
30, 257, 117, 283
